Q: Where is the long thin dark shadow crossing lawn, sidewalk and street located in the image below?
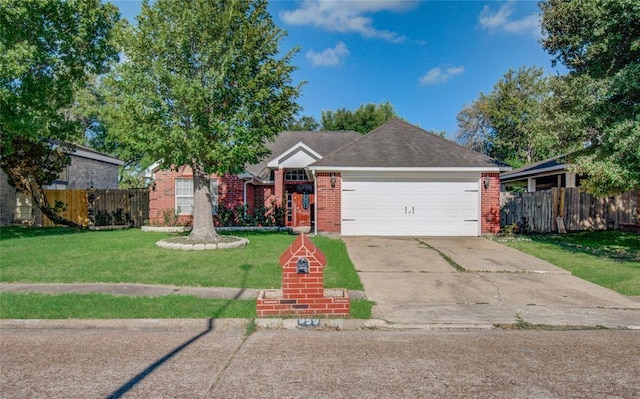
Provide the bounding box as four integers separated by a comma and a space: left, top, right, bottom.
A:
107, 264, 253, 399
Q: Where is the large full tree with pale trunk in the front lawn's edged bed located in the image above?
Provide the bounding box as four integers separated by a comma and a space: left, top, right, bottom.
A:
103, 0, 300, 241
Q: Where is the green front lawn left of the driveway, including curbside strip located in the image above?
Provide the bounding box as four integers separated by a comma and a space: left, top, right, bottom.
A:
0, 227, 371, 319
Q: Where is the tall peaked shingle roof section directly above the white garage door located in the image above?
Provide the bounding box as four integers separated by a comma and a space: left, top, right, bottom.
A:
311, 119, 500, 168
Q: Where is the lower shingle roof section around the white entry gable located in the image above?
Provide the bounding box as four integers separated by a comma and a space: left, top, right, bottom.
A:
246, 131, 362, 178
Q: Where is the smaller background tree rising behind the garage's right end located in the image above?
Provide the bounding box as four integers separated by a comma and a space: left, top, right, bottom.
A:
456, 67, 563, 167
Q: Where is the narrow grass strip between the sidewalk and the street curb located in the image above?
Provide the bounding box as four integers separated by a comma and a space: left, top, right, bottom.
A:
0, 293, 373, 319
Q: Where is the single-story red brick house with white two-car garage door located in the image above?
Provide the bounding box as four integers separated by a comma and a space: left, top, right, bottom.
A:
148, 119, 507, 236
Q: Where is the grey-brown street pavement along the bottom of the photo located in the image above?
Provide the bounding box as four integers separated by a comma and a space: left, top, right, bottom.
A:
0, 320, 640, 399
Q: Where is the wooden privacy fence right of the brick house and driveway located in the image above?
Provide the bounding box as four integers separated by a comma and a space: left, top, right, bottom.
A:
500, 188, 639, 233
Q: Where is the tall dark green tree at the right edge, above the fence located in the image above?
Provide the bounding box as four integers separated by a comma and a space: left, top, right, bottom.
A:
540, 0, 640, 194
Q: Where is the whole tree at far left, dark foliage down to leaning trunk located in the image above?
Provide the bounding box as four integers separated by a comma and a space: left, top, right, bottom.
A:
0, 0, 119, 225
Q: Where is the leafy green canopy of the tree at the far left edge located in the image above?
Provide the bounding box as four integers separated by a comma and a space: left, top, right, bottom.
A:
0, 0, 119, 155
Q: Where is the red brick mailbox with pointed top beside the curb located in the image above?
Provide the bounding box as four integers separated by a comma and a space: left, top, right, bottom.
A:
257, 234, 351, 317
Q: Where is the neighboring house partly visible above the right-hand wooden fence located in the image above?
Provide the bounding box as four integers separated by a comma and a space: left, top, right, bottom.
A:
500, 154, 581, 192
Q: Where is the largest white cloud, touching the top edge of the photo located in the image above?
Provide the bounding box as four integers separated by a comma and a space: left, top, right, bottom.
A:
280, 0, 416, 43
